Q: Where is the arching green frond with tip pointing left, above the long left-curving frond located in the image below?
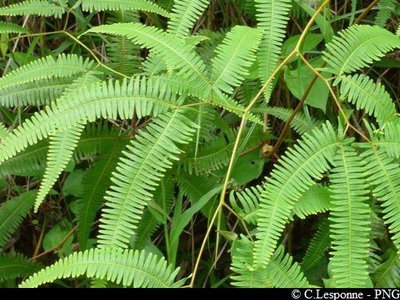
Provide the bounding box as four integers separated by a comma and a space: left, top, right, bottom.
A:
87, 23, 210, 94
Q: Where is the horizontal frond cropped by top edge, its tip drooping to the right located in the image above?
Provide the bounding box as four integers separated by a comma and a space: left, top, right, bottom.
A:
82, 0, 169, 17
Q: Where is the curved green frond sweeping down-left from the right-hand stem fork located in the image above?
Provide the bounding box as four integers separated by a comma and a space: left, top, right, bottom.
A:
254, 123, 340, 267
